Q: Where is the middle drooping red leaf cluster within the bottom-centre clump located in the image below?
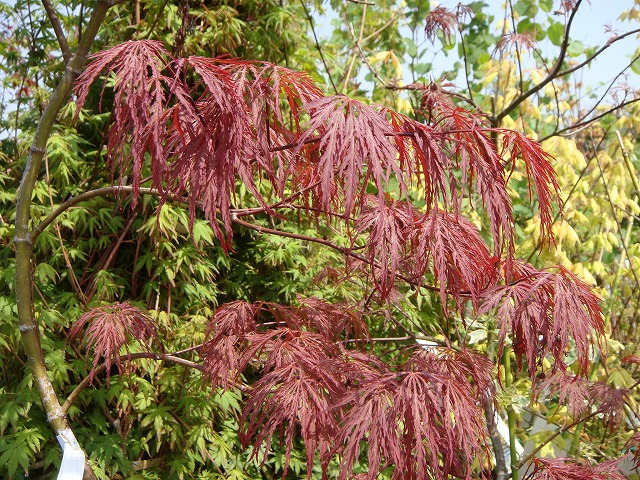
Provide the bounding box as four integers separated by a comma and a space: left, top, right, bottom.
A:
240, 328, 345, 478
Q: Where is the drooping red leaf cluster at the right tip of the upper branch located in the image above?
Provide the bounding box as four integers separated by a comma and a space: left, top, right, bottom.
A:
480, 262, 604, 378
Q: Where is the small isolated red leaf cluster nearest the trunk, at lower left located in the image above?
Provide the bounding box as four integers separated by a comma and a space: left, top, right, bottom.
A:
69, 302, 156, 381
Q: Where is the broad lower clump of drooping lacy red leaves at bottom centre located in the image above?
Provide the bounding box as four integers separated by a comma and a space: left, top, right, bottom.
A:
201, 299, 495, 479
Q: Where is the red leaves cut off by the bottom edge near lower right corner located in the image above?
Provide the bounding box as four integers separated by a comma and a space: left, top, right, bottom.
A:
523, 458, 624, 480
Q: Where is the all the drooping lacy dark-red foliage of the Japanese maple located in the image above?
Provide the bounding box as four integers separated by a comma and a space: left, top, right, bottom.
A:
62, 41, 616, 479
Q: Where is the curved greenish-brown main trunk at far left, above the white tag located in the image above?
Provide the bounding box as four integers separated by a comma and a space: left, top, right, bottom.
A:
14, 0, 111, 478
